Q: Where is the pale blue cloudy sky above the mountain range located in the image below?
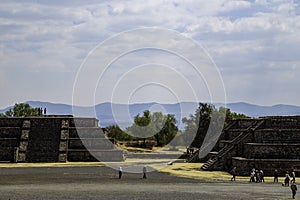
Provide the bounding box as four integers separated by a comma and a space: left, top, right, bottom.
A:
0, 0, 300, 108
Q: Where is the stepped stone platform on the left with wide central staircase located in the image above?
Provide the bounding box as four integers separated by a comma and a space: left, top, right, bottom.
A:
0, 116, 124, 162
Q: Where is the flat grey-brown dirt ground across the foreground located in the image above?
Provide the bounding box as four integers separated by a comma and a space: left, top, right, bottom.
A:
0, 165, 300, 200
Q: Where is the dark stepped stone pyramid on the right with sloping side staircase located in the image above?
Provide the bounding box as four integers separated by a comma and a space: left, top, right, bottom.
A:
189, 116, 300, 176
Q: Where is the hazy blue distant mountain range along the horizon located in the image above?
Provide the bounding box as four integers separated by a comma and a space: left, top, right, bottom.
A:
0, 101, 300, 128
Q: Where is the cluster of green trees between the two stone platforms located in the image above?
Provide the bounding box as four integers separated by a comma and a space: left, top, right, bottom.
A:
107, 103, 249, 148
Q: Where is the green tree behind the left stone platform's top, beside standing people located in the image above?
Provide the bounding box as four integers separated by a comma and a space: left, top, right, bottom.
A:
5, 103, 39, 117
